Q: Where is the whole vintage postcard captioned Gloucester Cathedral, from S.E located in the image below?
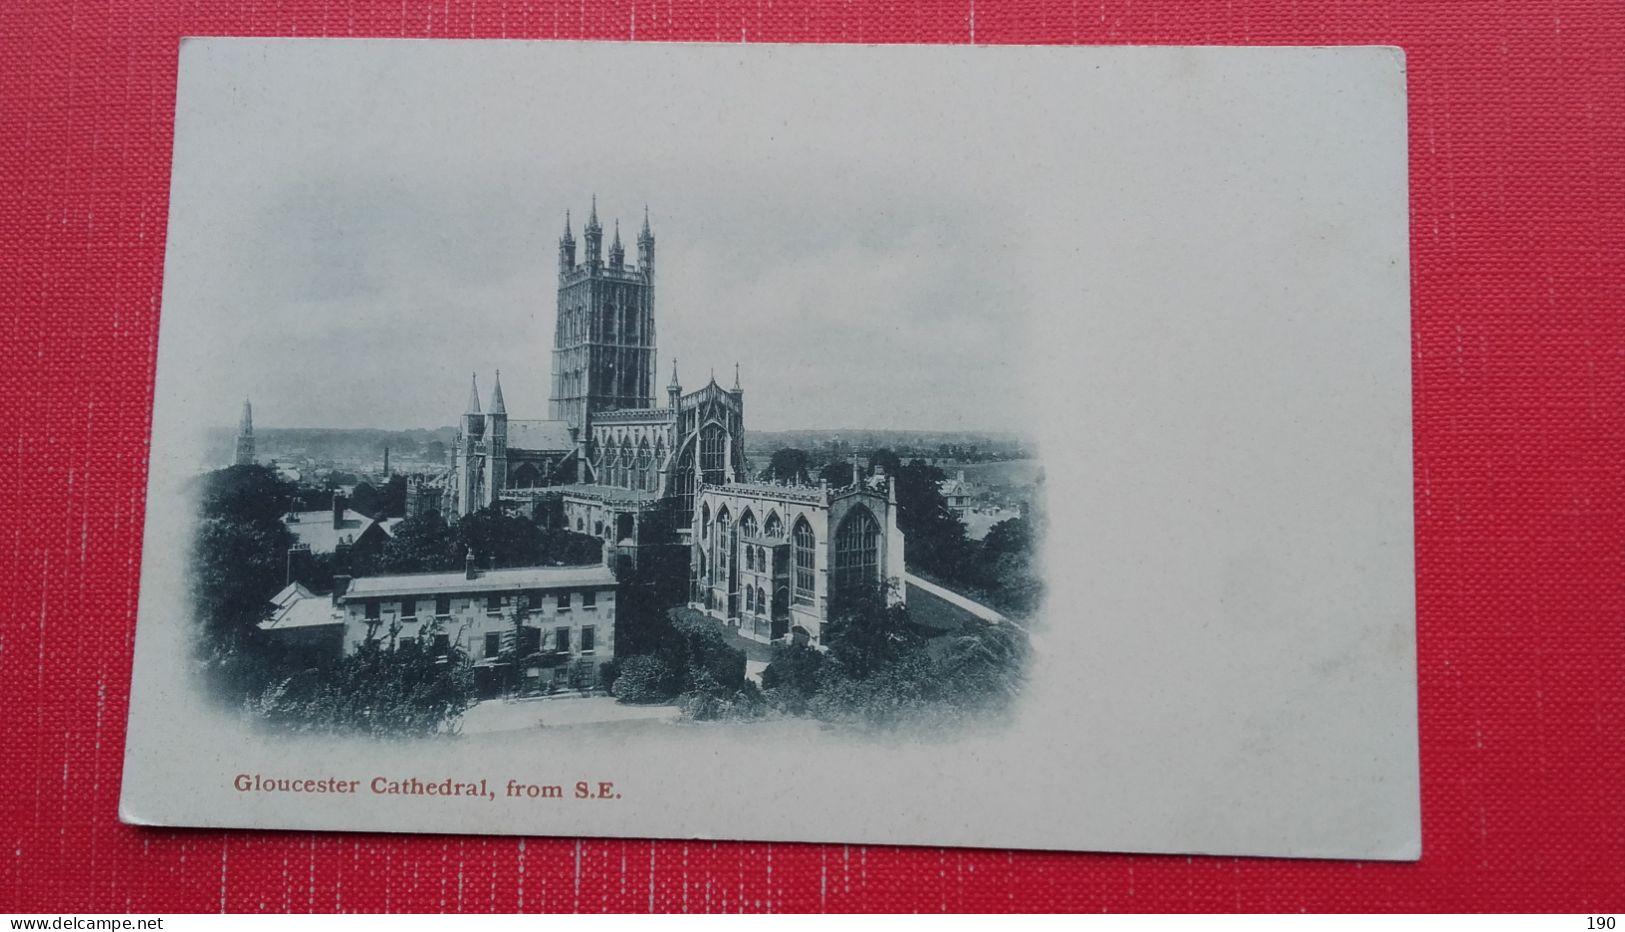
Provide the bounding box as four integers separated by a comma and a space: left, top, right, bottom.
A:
122, 39, 1420, 859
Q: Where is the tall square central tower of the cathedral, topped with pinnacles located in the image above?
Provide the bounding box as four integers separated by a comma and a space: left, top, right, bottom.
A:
548, 196, 657, 432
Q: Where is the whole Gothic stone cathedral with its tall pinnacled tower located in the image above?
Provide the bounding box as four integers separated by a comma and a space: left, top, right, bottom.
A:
408, 198, 904, 645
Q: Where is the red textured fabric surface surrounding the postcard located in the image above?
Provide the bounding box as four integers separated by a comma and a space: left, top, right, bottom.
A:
0, 0, 1625, 913
